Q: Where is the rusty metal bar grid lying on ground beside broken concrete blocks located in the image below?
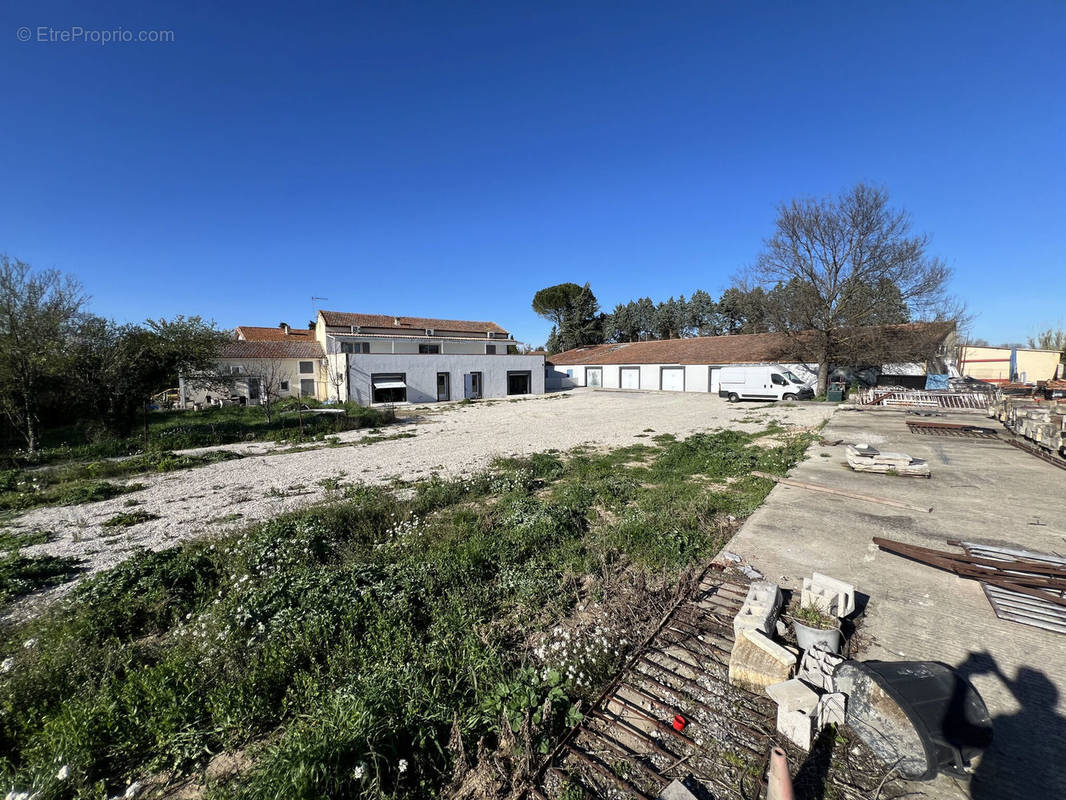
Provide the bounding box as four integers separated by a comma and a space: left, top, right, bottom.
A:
531, 567, 775, 800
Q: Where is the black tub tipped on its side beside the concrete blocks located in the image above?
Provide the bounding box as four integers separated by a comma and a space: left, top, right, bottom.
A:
833, 661, 992, 781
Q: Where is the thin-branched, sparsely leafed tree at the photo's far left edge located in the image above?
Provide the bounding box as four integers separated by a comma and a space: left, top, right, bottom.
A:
0, 255, 85, 453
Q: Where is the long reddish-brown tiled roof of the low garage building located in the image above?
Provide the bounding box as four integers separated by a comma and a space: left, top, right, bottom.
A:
548, 322, 954, 365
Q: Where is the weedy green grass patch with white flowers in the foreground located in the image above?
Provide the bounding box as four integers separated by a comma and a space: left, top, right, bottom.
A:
0, 422, 810, 800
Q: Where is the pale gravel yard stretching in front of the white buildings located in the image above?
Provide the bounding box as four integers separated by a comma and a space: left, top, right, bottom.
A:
10, 389, 835, 584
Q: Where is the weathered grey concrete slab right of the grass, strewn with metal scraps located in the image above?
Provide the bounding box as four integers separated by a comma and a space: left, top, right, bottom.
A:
727, 410, 1066, 800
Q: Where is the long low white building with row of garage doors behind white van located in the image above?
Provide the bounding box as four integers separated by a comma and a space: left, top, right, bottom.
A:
547, 323, 952, 394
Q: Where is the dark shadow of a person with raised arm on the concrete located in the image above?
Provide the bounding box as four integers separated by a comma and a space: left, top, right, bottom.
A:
957, 653, 1066, 800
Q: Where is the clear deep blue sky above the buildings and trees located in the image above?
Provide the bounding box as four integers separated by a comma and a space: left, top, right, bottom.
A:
0, 0, 1066, 343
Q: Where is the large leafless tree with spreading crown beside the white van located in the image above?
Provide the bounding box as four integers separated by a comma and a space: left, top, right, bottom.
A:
752, 183, 962, 394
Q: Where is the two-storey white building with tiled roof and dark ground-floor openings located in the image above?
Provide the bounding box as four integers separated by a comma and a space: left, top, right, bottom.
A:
313, 310, 545, 405
